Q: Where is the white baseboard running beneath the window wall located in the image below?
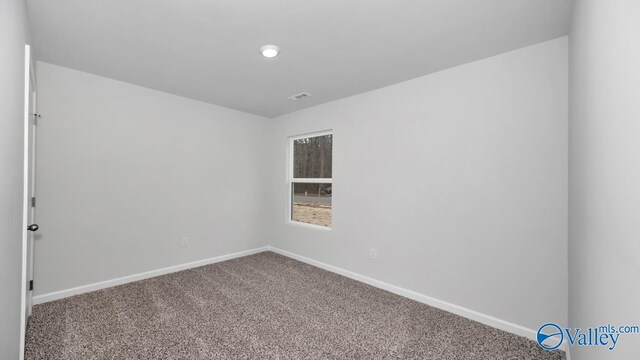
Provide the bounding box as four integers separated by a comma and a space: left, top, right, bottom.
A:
268, 246, 537, 341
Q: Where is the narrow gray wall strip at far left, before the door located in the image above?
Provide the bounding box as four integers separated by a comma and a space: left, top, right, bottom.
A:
0, 0, 29, 359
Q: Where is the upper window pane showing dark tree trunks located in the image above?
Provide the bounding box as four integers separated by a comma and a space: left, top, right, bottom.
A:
293, 135, 333, 179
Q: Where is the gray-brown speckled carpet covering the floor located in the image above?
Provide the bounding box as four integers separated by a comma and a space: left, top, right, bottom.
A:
26, 252, 564, 360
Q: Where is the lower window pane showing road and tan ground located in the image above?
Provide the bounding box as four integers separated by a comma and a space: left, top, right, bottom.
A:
291, 183, 332, 227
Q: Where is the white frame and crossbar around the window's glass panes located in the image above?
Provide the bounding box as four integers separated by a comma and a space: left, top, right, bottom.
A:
287, 130, 334, 231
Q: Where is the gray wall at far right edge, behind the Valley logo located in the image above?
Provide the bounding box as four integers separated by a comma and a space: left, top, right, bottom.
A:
569, 0, 640, 360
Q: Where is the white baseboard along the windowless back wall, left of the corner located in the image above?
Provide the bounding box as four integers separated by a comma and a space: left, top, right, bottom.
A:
33, 246, 269, 305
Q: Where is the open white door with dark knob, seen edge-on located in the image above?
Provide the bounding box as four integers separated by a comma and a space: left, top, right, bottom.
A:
20, 45, 39, 359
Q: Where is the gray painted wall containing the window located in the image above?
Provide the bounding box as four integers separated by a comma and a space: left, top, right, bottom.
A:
270, 37, 568, 329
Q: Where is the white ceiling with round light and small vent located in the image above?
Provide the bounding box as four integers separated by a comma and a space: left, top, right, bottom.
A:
28, 0, 570, 117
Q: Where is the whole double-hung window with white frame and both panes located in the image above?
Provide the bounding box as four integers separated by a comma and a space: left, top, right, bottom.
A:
289, 131, 333, 229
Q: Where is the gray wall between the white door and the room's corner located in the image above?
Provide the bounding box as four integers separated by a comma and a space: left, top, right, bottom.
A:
34, 62, 270, 295
